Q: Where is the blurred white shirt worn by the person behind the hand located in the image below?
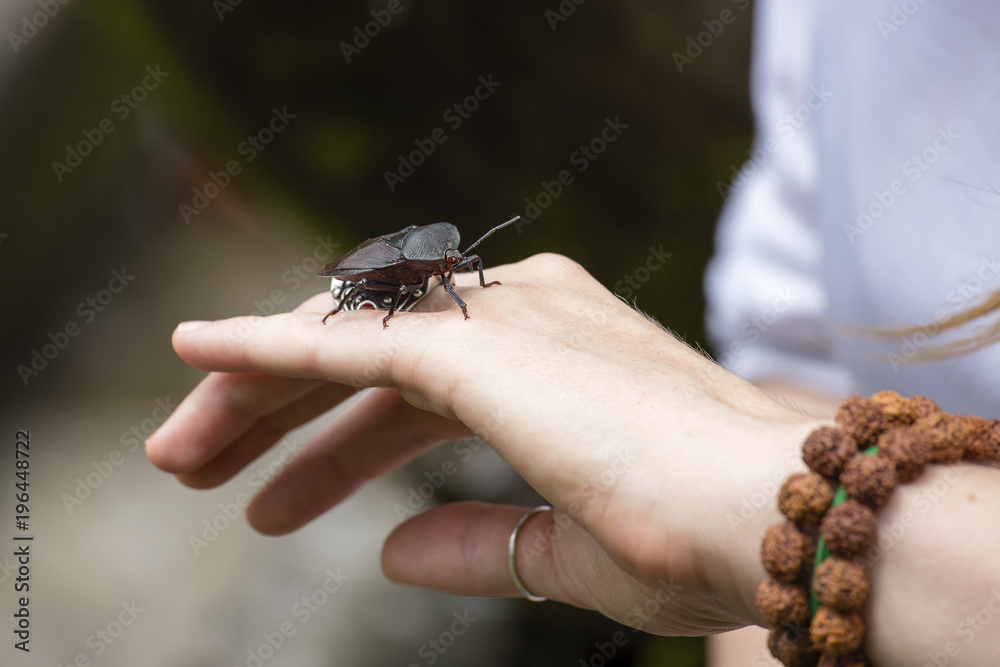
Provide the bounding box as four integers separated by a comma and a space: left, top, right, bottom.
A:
705, 0, 1000, 416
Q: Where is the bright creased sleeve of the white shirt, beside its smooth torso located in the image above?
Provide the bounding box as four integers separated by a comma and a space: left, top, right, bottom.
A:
705, 0, 852, 394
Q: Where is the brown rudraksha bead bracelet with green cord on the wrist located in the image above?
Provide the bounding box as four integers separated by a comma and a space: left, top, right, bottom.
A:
756, 391, 1000, 667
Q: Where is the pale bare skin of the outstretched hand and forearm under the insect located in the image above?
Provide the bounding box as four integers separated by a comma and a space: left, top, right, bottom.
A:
147, 255, 1000, 665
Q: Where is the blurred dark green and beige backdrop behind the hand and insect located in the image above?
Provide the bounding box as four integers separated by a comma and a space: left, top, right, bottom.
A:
0, 0, 752, 667
